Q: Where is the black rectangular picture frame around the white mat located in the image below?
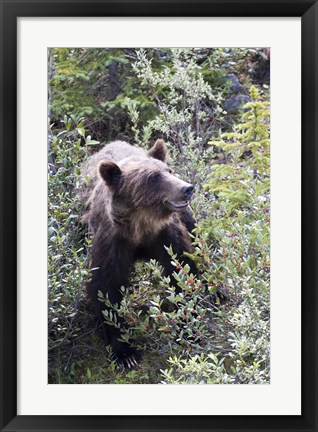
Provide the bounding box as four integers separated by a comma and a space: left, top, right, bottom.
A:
0, 0, 318, 432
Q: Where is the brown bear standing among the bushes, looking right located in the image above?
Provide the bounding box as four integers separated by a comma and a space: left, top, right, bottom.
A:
81, 139, 197, 366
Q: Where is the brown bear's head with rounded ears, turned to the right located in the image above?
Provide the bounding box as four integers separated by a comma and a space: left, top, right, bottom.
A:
99, 139, 194, 238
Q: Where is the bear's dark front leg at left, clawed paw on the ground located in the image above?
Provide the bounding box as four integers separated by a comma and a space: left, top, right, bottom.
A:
88, 240, 140, 367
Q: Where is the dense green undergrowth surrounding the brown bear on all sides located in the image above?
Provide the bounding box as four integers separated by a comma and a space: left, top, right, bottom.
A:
48, 49, 270, 384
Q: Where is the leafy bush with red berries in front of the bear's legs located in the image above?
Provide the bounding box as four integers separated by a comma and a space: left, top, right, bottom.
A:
99, 240, 226, 362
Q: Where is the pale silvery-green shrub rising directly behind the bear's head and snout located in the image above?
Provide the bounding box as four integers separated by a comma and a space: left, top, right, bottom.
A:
123, 49, 223, 184
